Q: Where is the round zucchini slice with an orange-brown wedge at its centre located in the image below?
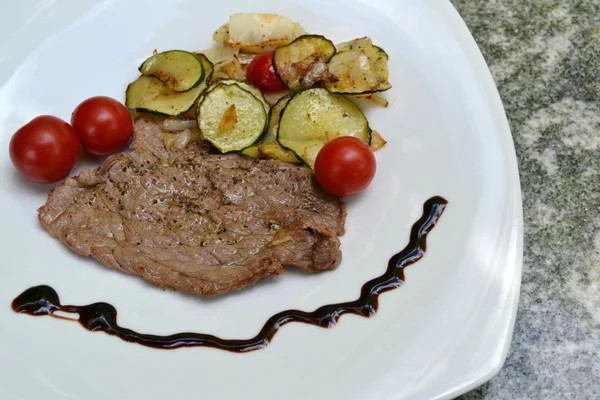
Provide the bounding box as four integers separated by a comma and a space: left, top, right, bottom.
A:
196, 84, 268, 153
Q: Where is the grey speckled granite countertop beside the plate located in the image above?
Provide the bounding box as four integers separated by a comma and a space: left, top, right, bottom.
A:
452, 0, 600, 400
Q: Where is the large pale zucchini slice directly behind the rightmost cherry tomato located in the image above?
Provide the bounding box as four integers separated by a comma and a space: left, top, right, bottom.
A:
277, 88, 371, 168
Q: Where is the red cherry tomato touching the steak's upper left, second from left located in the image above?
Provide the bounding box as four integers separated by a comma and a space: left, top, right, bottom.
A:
71, 96, 133, 156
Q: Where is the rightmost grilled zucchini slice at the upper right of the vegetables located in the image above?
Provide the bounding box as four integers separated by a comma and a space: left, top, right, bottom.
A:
325, 44, 392, 94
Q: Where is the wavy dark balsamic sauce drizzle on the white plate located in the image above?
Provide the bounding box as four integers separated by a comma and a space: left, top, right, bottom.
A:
12, 196, 448, 352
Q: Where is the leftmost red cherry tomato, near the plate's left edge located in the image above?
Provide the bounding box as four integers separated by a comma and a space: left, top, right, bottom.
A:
9, 115, 79, 183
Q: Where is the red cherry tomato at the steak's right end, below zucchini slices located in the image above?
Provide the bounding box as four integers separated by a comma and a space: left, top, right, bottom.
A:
315, 136, 376, 196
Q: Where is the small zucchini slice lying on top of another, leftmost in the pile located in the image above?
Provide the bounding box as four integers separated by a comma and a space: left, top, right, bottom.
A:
139, 50, 204, 92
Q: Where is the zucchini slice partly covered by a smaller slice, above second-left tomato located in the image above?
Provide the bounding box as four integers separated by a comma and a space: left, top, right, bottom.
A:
125, 55, 213, 117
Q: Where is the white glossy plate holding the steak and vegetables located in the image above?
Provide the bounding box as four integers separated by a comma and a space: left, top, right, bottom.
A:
0, 0, 522, 400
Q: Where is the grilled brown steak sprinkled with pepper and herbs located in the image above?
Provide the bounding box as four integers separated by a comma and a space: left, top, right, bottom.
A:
38, 118, 346, 295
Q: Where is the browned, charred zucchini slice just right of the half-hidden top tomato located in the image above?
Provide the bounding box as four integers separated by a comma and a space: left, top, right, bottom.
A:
273, 35, 336, 91
